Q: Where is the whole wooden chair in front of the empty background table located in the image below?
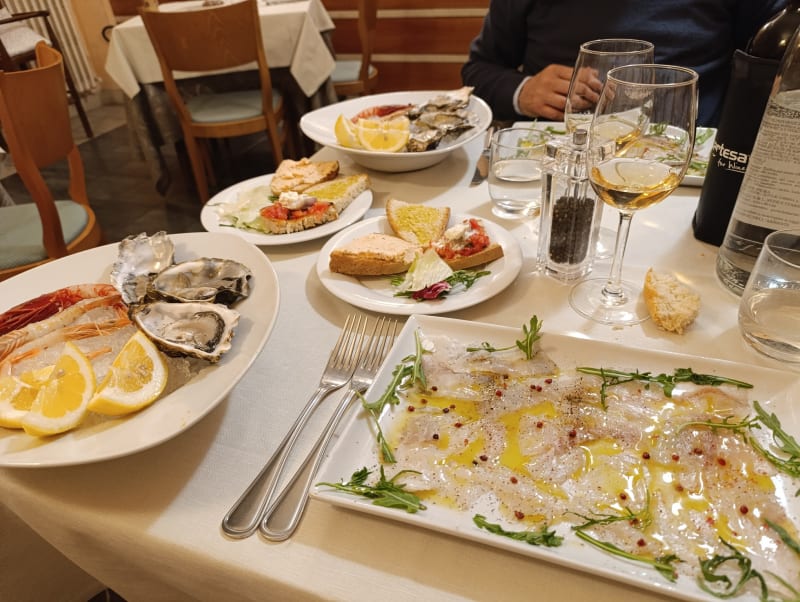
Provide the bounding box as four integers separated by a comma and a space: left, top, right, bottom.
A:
140, 0, 288, 203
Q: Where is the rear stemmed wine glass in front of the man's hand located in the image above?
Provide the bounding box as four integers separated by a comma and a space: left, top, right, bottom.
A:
564, 38, 653, 259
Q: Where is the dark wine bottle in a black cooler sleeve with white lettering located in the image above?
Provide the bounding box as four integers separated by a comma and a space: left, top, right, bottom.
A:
692, 0, 800, 246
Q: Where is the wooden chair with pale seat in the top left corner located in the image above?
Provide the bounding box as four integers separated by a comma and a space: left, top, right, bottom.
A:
0, 1, 94, 138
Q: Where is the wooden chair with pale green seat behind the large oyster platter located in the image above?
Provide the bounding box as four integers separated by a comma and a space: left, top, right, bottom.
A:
0, 42, 102, 280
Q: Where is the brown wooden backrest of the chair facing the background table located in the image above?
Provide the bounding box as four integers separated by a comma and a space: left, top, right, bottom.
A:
139, 0, 272, 119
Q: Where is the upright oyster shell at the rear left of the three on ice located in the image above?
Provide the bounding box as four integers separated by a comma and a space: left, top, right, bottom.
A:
111, 230, 175, 305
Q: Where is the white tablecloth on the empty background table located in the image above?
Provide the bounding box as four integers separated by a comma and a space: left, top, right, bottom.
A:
105, 0, 335, 98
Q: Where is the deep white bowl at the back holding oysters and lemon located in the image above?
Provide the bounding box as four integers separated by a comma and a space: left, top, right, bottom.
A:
300, 90, 492, 173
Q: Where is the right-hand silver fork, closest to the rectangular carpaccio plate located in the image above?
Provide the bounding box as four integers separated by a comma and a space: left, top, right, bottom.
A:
260, 318, 397, 541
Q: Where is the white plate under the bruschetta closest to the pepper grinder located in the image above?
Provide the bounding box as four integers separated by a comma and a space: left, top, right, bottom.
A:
317, 215, 522, 316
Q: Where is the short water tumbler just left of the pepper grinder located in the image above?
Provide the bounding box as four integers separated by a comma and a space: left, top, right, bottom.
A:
489, 127, 551, 219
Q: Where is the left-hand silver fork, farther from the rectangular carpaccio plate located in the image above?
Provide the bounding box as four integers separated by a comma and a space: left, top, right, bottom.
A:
222, 314, 367, 538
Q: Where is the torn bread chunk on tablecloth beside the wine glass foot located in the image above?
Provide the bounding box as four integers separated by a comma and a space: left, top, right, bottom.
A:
644, 268, 700, 334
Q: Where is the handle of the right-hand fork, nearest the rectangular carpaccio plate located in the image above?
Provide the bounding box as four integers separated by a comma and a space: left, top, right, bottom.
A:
260, 389, 359, 541
